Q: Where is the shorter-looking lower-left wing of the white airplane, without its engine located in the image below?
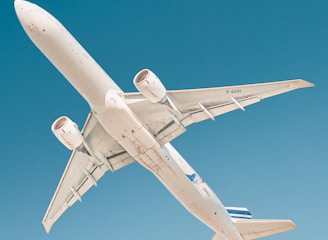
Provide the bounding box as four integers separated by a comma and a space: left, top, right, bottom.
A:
42, 113, 134, 232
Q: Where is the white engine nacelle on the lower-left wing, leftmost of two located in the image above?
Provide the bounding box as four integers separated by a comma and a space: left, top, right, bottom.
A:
51, 116, 83, 150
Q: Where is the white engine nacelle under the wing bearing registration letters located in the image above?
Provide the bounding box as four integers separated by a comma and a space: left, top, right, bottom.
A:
133, 69, 166, 103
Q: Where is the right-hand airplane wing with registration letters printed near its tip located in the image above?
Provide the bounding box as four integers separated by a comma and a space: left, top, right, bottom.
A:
124, 79, 313, 144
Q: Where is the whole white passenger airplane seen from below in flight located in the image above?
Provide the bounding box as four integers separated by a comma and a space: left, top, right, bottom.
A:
15, 0, 313, 240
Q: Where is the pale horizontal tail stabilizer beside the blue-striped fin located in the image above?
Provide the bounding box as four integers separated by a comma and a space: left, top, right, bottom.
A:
234, 220, 296, 240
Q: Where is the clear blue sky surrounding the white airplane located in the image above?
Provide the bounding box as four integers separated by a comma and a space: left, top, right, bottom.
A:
0, 0, 328, 240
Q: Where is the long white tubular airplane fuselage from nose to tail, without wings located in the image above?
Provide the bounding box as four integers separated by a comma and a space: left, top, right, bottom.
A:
16, 1, 242, 240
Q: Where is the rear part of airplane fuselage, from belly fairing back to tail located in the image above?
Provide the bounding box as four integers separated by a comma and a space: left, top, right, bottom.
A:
96, 90, 240, 240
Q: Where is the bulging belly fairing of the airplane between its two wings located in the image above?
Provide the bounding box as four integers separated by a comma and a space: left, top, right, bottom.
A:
95, 90, 164, 171
